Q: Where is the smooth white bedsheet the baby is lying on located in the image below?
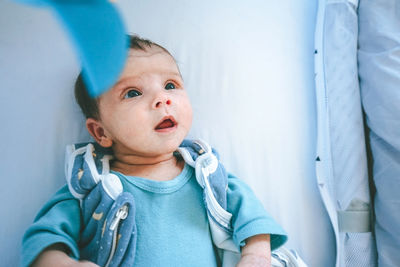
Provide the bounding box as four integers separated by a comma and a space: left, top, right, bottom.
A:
0, 0, 335, 266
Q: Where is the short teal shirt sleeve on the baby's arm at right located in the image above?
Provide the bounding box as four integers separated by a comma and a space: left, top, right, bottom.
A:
227, 174, 287, 250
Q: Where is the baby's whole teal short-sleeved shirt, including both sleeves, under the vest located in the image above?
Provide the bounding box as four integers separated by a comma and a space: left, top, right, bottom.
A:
22, 164, 286, 267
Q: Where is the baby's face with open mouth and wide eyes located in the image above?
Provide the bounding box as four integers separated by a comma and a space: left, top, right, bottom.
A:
95, 46, 192, 157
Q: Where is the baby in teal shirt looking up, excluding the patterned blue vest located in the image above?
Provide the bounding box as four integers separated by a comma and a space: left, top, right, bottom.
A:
23, 36, 286, 267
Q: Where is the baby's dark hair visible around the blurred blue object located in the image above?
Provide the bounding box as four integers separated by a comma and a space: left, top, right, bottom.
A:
75, 35, 172, 120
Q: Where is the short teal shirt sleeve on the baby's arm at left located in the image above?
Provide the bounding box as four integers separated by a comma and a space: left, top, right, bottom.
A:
21, 186, 81, 266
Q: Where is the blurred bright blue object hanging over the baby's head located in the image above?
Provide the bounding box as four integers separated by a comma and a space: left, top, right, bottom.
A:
15, 0, 128, 97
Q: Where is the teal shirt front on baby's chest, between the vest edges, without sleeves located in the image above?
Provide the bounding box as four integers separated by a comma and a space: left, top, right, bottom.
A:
111, 165, 217, 267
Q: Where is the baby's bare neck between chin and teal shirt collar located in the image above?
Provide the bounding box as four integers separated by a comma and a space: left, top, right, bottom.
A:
111, 154, 185, 181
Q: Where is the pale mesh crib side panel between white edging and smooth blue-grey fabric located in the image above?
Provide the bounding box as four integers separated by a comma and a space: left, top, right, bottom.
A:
324, 1, 376, 266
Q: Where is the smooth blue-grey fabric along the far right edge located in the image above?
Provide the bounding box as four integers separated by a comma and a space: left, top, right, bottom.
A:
358, 0, 400, 266
